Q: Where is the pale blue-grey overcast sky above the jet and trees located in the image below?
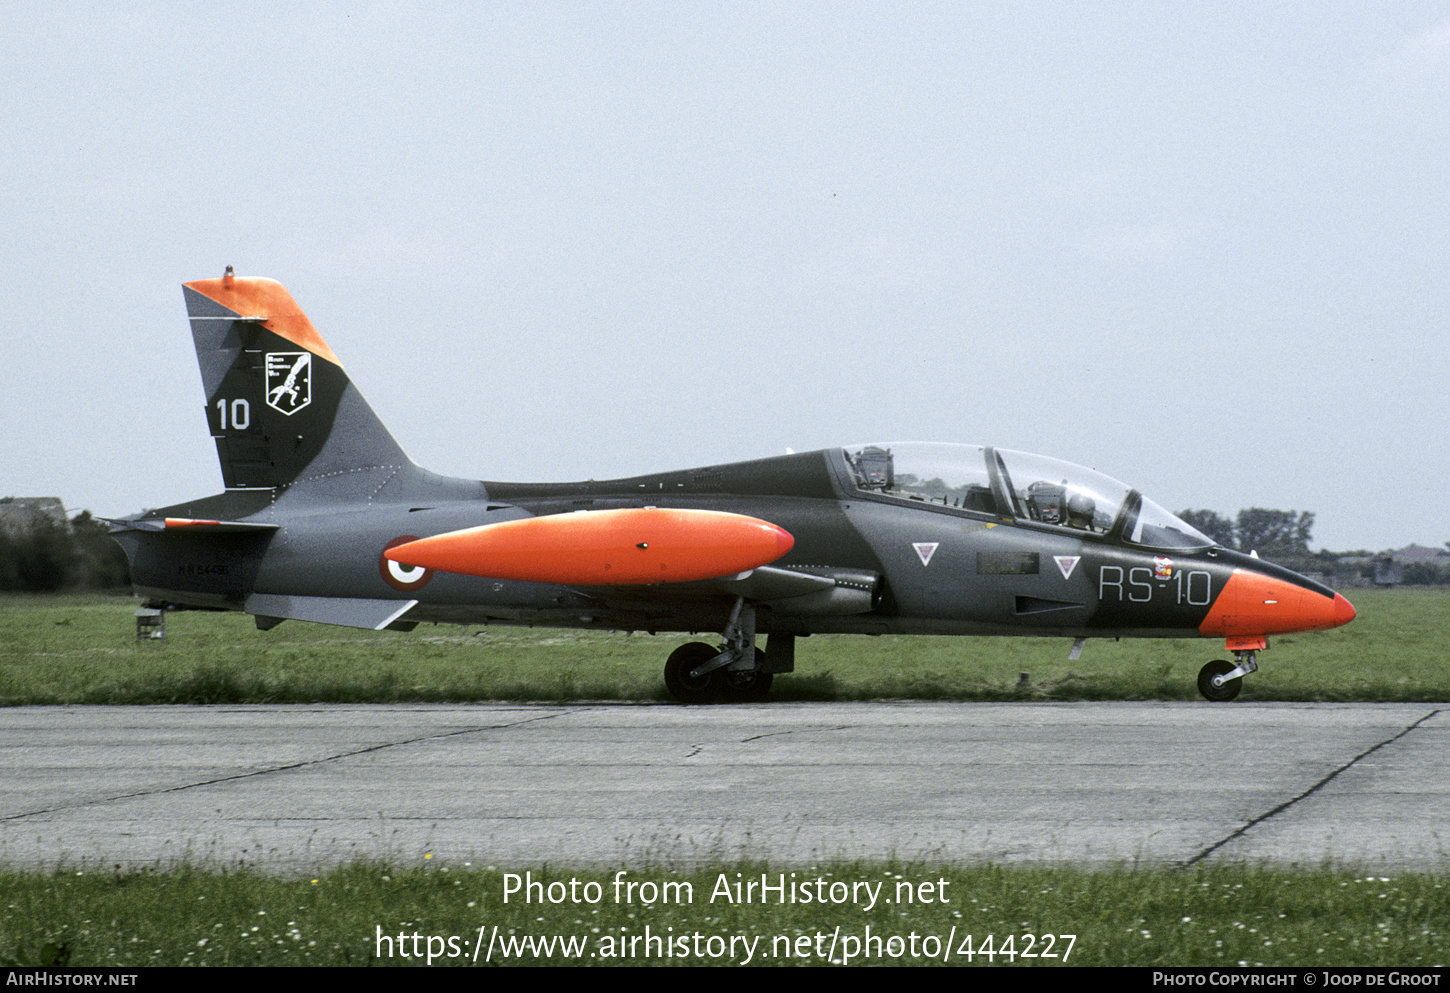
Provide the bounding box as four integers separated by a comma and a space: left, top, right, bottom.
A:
0, 0, 1450, 551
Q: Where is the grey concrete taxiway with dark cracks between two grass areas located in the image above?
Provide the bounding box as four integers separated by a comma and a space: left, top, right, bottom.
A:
0, 703, 1450, 871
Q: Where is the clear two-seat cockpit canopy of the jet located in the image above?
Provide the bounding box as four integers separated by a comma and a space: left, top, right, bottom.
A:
844, 442, 1214, 549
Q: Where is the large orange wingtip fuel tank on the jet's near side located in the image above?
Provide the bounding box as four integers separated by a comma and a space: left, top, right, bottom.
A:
383, 507, 796, 586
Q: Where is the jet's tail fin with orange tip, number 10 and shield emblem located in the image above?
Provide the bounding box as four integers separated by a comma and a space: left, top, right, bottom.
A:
183, 267, 418, 490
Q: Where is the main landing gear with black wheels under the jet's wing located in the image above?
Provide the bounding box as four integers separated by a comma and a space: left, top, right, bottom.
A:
664, 597, 795, 703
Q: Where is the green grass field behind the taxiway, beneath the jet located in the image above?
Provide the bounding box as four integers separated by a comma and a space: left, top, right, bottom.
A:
0, 589, 1450, 706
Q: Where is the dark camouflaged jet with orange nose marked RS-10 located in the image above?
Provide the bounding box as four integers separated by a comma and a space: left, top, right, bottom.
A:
112, 267, 1354, 703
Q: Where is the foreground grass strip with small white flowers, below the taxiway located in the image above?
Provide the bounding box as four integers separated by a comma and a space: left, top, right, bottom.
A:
0, 864, 1450, 967
